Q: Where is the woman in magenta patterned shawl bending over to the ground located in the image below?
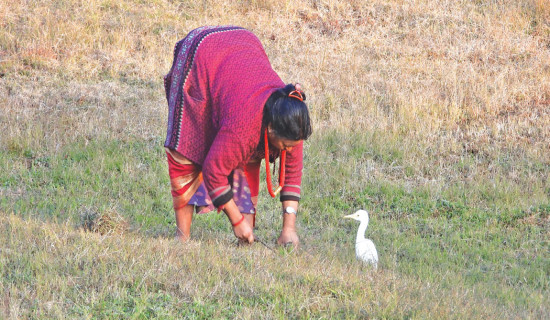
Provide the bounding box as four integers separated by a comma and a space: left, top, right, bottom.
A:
164, 26, 311, 245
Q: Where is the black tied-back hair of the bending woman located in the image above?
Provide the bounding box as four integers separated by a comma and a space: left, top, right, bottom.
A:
262, 84, 312, 141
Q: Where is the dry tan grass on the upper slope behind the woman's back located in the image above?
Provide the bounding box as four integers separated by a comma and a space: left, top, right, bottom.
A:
0, 0, 550, 188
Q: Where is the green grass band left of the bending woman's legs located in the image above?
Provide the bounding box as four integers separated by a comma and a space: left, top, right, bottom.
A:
1, 140, 170, 226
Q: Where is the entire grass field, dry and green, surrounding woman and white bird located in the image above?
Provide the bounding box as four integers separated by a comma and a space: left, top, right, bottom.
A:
0, 0, 550, 319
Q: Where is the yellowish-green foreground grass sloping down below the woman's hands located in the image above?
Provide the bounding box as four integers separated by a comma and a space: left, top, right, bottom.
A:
0, 210, 546, 319
